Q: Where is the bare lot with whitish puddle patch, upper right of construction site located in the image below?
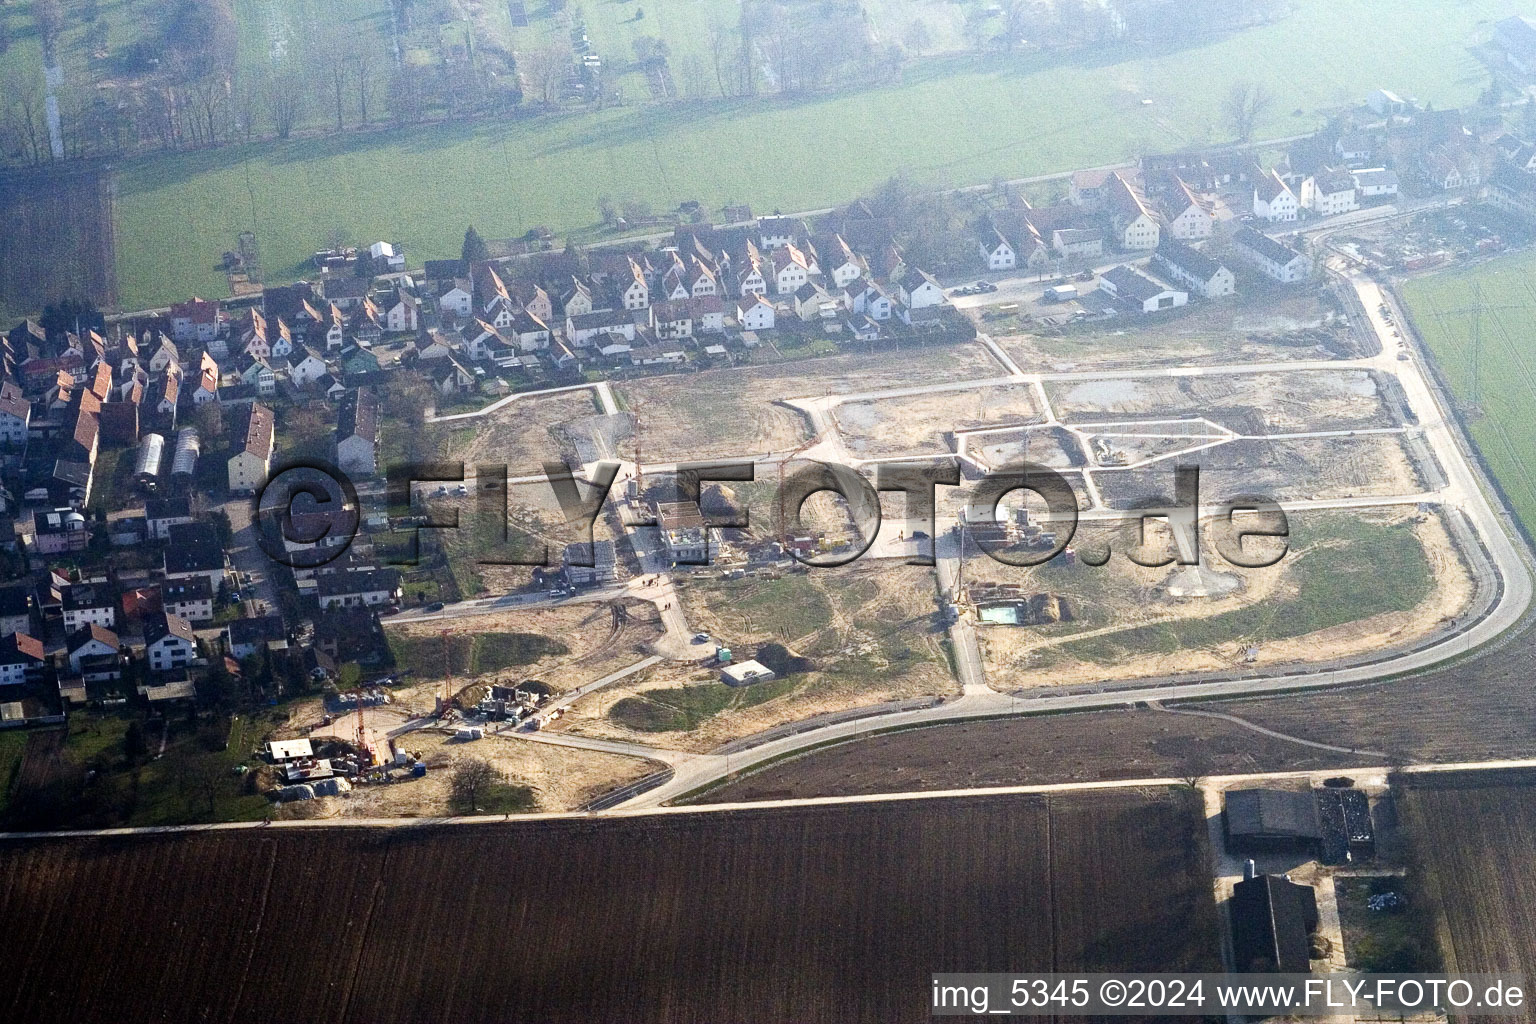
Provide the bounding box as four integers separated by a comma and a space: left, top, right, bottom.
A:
1046, 370, 1396, 434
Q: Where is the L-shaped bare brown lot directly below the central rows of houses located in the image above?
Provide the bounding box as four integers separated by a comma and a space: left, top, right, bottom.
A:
617, 342, 1003, 462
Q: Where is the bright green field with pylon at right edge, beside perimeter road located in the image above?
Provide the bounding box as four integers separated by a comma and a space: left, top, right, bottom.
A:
1402, 253, 1536, 533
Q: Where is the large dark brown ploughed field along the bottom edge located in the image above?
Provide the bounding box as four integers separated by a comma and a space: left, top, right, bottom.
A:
0, 789, 1220, 1024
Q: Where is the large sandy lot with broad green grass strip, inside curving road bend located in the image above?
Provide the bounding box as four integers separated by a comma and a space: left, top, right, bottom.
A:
965, 511, 1473, 689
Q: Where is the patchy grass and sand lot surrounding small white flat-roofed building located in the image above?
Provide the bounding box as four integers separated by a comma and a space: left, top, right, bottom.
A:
556, 562, 957, 751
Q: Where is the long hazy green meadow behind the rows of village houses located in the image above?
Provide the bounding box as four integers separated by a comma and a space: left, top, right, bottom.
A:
29, 0, 1521, 309
